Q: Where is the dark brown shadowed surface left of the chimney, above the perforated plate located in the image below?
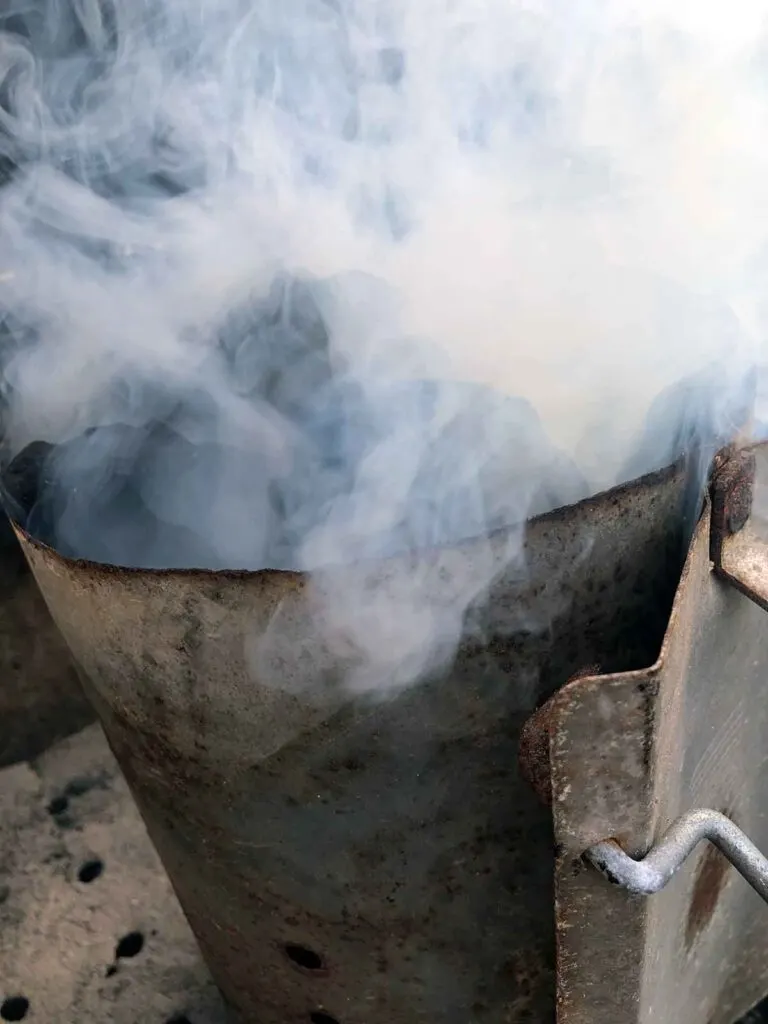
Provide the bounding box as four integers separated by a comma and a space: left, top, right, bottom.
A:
0, 513, 94, 767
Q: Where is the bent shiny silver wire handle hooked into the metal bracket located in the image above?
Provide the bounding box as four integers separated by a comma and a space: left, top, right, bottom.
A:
585, 809, 768, 903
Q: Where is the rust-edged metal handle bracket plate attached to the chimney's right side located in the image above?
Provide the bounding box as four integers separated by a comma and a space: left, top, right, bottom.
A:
549, 450, 768, 1024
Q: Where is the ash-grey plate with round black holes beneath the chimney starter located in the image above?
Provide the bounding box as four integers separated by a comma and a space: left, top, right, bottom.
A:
0, 726, 224, 1024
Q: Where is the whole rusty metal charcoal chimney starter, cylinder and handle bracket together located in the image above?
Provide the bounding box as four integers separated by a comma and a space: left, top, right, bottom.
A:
10, 452, 768, 1024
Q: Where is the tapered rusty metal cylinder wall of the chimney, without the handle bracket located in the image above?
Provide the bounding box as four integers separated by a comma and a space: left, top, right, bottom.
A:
9, 454, 686, 1024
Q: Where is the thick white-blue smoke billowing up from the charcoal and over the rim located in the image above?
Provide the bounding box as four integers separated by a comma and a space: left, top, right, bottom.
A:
0, 0, 768, 688
